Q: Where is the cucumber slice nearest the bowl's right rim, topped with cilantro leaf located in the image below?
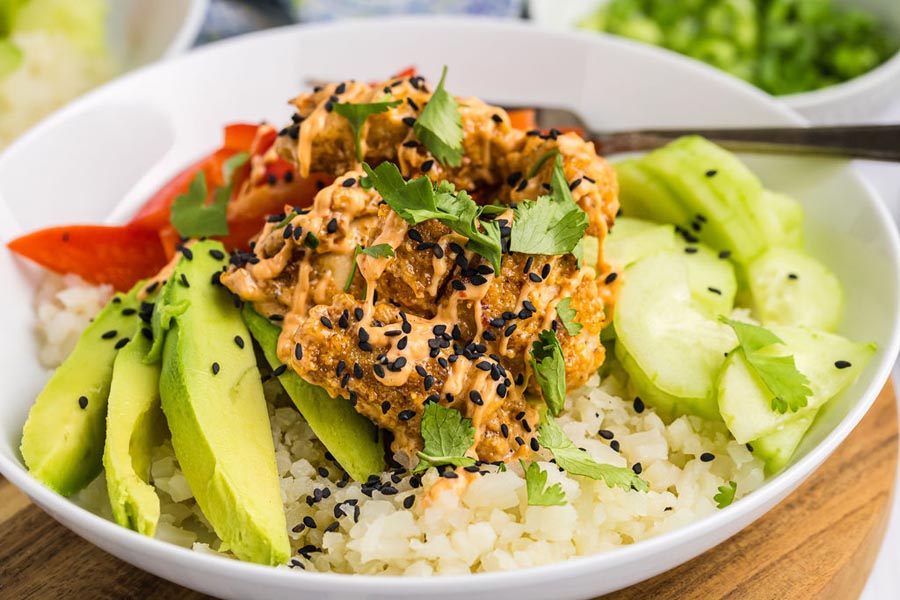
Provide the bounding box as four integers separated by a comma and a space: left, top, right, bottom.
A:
718, 326, 875, 444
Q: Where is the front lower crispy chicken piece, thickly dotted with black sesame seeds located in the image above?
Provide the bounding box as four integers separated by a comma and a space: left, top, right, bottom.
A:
287, 294, 537, 460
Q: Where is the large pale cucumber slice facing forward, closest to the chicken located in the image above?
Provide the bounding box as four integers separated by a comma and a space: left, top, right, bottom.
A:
614, 253, 737, 419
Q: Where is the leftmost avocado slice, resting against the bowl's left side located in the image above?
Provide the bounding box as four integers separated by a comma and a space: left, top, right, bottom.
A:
20, 283, 142, 496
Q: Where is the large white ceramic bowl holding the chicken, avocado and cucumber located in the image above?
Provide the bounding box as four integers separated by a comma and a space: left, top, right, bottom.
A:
0, 19, 898, 600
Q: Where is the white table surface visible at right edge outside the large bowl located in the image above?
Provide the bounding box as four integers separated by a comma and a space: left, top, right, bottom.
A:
859, 98, 900, 600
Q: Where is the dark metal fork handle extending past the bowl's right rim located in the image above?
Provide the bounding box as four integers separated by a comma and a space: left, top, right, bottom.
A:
591, 125, 900, 162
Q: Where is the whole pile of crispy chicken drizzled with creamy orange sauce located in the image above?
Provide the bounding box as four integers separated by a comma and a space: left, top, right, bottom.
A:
221, 77, 618, 464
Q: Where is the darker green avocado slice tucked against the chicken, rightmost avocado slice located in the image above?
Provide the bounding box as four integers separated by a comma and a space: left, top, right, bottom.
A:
243, 304, 385, 481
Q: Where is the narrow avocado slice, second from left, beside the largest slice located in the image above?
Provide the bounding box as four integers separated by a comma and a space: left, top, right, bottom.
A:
103, 335, 165, 537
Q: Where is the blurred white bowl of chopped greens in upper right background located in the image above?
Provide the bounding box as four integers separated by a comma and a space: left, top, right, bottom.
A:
528, 0, 900, 124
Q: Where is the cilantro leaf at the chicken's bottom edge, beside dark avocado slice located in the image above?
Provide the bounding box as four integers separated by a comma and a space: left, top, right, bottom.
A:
414, 402, 475, 472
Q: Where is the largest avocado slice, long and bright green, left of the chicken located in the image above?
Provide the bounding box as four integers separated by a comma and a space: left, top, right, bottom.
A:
160, 241, 291, 565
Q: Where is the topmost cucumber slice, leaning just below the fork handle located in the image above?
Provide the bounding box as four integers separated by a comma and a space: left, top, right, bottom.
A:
642, 137, 765, 265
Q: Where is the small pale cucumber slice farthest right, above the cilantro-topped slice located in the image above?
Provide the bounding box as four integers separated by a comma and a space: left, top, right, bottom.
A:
747, 248, 843, 331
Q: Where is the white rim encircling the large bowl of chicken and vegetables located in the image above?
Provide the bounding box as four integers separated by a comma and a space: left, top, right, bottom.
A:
0, 16, 900, 596
